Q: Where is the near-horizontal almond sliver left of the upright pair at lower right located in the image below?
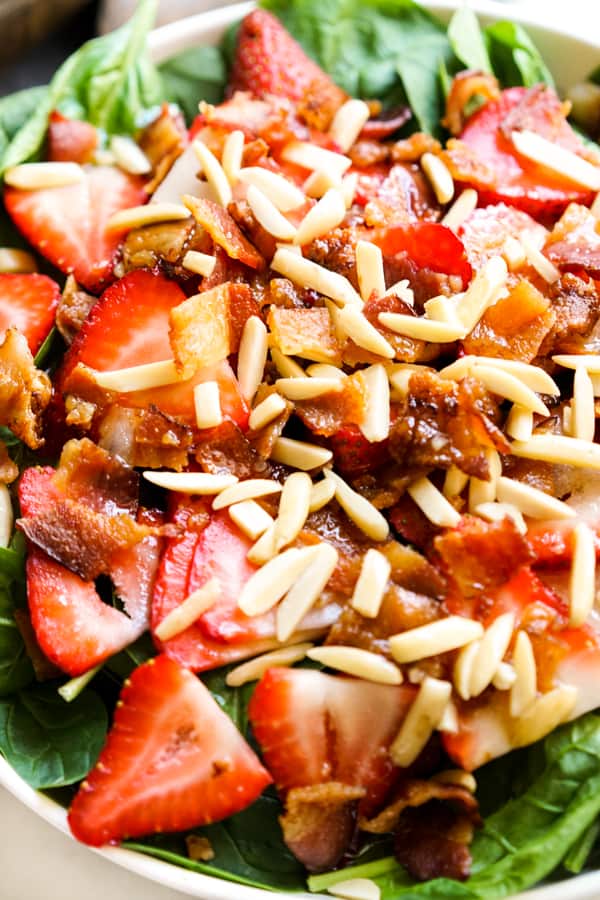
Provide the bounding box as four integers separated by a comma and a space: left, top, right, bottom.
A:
390, 616, 483, 663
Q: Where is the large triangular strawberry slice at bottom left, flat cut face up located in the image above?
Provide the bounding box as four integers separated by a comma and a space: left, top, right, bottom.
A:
69, 656, 271, 847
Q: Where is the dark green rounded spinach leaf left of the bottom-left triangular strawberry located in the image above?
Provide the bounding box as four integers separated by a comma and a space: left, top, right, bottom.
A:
0, 685, 108, 788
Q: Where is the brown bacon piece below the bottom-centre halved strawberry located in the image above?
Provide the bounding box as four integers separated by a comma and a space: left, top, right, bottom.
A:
279, 781, 366, 872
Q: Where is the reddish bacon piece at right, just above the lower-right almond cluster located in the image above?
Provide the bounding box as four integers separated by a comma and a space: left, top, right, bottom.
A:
433, 516, 533, 597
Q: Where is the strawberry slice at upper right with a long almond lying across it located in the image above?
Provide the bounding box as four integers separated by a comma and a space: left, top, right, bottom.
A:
461, 86, 591, 218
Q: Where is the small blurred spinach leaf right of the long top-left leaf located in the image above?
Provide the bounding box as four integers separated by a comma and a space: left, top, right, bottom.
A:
159, 47, 227, 123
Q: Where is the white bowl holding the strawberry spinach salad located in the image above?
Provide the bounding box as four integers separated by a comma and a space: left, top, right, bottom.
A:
0, 0, 600, 900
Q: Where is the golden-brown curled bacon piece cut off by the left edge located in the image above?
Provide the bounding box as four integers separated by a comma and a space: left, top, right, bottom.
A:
0, 328, 52, 450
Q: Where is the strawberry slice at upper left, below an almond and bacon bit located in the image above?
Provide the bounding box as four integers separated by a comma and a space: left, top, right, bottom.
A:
4, 166, 148, 293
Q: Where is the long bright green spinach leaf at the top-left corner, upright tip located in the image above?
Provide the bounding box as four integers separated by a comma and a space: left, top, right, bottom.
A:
0, 0, 162, 172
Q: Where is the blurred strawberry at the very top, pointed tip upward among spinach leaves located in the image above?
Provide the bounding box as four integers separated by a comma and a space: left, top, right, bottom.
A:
229, 9, 346, 106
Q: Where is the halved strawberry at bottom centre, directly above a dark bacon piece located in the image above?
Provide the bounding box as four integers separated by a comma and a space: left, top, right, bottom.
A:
248, 669, 415, 814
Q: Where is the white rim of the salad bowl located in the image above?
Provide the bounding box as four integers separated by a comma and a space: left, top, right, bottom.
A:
0, 0, 600, 900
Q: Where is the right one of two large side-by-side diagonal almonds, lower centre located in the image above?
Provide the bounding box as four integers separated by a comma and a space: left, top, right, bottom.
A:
275, 542, 338, 641
